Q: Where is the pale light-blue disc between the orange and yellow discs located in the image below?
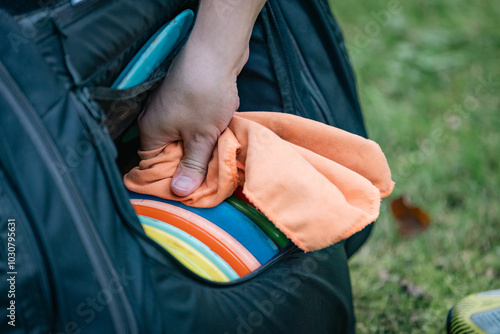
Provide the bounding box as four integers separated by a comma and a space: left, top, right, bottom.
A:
138, 215, 240, 280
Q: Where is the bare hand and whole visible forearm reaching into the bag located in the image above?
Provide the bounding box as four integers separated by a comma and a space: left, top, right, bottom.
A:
138, 0, 265, 197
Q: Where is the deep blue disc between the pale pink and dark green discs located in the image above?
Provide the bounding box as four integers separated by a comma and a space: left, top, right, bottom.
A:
129, 191, 279, 264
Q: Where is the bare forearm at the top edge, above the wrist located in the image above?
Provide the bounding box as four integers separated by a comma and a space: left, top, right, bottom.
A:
186, 0, 265, 73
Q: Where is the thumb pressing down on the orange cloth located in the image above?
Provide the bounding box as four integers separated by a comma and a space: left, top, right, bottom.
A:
170, 137, 217, 197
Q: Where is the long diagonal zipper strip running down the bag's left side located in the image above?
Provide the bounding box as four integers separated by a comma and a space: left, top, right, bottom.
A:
0, 62, 138, 333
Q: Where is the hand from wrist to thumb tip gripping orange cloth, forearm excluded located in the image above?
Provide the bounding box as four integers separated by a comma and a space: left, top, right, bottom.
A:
138, 40, 249, 196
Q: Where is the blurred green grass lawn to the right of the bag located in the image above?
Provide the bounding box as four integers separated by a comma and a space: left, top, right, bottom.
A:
331, 0, 500, 333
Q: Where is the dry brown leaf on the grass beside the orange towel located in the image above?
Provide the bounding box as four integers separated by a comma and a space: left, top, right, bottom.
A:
391, 196, 431, 237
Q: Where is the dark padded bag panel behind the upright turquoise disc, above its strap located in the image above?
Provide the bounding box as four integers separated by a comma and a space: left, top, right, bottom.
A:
16, 0, 199, 87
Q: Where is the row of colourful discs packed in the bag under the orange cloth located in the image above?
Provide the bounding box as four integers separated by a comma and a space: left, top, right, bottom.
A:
130, 192, 289, 282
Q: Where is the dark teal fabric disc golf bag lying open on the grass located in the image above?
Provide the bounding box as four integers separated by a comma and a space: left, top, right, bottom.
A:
0, 0, 366, 333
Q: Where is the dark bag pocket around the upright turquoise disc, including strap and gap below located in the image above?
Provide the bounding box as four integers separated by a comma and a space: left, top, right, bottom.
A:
16, 0, 199, 139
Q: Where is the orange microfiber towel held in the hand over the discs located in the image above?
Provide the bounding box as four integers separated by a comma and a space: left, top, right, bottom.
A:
124, 112, 394, 251
